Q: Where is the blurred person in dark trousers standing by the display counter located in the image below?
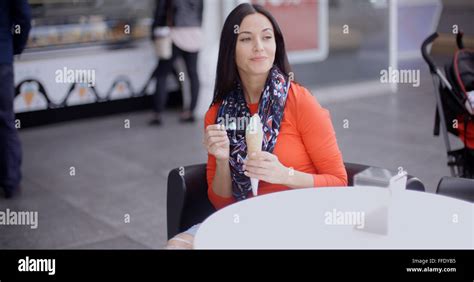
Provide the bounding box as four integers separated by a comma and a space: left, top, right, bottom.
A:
150, 0, 204, 125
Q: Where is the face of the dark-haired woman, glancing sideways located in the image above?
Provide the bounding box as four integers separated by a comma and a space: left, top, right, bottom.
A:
235, 13, 276, 78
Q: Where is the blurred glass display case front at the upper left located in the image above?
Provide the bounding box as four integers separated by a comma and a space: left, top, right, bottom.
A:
27, 0, 154, 51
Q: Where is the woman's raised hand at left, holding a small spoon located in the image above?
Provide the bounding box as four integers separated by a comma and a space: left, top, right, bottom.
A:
203, 124, 230, 161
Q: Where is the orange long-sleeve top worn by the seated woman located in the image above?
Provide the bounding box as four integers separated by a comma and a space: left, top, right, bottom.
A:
204, 82, 347, 209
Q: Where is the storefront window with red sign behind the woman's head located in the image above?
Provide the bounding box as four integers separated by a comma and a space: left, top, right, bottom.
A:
226, 0, 389, 88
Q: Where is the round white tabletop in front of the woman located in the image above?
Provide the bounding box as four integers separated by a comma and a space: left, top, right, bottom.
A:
194, 187, 474, 249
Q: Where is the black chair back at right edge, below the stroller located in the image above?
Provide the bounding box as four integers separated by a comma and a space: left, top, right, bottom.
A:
436, 176, 474, 203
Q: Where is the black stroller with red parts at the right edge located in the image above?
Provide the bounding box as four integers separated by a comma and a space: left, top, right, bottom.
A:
421, 32, 474, 178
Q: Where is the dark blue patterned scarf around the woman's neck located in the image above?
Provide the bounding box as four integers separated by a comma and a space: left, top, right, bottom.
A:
217, 66, 290, 201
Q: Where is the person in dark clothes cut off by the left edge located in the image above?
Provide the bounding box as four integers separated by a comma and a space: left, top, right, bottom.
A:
0, 0, 31, 198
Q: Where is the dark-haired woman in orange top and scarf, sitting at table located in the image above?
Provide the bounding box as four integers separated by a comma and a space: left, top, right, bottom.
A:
167, 4, 347, 248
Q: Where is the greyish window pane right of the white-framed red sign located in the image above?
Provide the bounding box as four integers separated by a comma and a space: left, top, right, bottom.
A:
294, 0, 389, 88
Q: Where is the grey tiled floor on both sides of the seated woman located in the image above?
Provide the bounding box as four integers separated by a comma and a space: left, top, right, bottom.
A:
0, 58, 460, 249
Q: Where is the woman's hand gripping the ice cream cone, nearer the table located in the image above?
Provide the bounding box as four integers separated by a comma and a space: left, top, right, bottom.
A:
243, 151, 290, 185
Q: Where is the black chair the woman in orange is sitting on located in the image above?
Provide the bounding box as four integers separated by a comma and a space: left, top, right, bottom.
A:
166, 163, 425, 239
